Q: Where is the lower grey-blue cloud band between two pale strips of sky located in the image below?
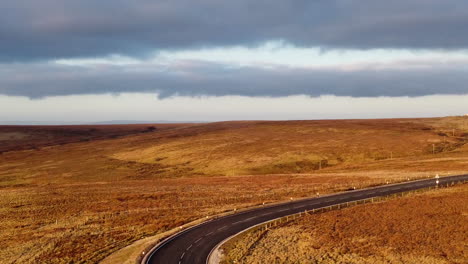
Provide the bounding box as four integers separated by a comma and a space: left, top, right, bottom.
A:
0, 61, 468, 98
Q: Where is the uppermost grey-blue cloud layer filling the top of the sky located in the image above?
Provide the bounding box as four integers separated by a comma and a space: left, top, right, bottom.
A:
0, 0, 468, 61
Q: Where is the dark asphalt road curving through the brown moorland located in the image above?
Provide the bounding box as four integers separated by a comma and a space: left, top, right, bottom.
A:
142, 174, 468, 264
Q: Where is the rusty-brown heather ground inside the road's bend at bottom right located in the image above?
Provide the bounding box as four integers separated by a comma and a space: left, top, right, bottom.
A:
223, 184, 468, 264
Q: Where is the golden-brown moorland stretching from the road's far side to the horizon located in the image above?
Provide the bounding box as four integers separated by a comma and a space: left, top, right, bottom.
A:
0, 117, 468, 263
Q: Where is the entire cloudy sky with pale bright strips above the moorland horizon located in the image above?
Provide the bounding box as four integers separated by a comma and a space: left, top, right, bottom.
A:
0, 0, 468, 124
